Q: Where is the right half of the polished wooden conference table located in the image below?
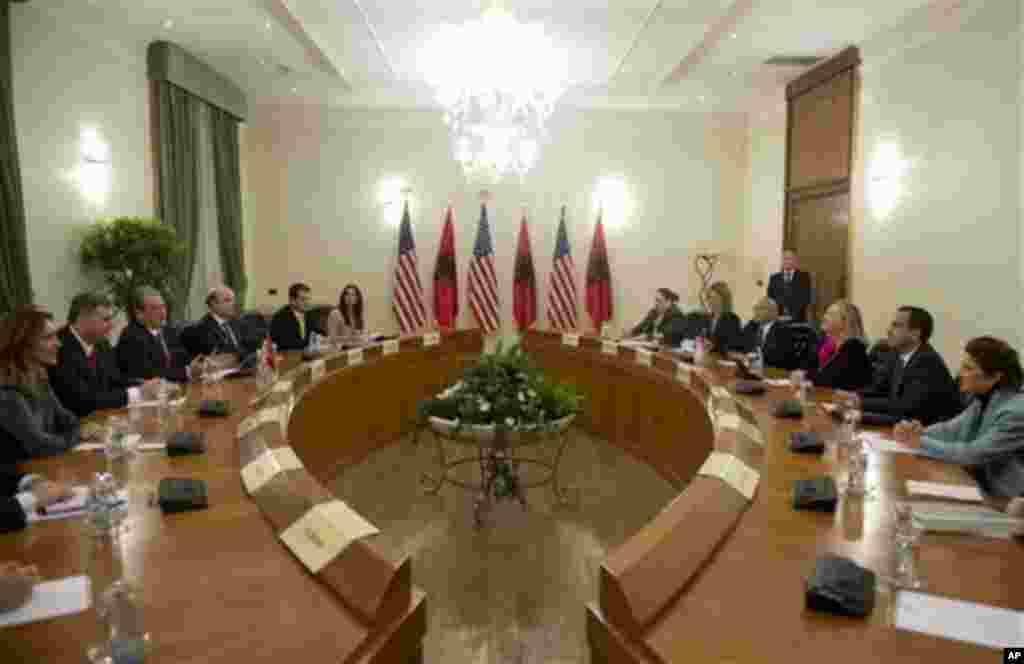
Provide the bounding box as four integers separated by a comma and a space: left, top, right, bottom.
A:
522, 332, 1024, 664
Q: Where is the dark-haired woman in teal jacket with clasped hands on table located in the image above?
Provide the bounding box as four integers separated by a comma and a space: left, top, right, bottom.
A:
893, 337, 1024, 508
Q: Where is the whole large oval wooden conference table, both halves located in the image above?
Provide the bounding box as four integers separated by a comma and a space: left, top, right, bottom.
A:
0, 332, 1024, 663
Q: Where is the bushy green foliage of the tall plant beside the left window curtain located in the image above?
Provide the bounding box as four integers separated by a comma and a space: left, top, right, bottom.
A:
79, 217, 185, 310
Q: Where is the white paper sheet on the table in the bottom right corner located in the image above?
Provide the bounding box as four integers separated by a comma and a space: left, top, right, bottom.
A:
894, 590, 1024, 649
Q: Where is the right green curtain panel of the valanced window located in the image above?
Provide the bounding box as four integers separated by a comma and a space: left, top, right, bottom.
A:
210, 106, 248, 306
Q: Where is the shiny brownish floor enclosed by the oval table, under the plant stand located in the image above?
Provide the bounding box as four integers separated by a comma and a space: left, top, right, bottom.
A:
333, 432, 676, 664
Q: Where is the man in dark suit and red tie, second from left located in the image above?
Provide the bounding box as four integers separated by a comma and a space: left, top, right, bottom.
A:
49, 293, 159, 417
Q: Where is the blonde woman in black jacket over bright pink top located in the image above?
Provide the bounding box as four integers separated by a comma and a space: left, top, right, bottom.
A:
813, 299, 873, 389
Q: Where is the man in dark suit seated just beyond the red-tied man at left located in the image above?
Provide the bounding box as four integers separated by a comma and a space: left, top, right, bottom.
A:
116, 286, 203, 382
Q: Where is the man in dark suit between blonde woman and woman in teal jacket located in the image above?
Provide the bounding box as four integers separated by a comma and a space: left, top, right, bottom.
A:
842, 306, 962, 426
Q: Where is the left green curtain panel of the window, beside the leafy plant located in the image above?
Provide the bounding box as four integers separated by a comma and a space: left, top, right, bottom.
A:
154, 81, 202, 317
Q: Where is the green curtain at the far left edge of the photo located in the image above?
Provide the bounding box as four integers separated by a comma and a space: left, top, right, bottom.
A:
0, 0, 33, 316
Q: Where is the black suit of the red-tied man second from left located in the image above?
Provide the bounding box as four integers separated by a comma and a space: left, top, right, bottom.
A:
49, 327, 139, 417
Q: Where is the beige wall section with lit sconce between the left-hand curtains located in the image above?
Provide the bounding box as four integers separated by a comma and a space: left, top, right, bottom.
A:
10, 3, 153, 320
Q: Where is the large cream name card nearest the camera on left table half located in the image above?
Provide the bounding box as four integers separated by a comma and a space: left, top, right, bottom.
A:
281, 500, 380, 574
